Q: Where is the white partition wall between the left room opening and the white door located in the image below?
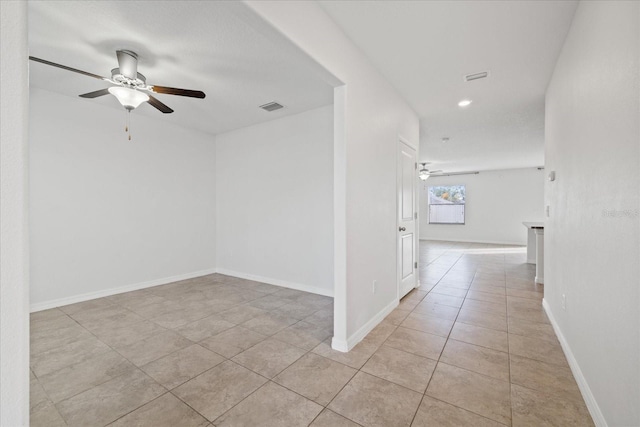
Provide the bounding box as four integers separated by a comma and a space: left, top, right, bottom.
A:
245, 1, 419, 351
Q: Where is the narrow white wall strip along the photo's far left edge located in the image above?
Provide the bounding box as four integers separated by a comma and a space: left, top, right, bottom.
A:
0, 1, 29, 426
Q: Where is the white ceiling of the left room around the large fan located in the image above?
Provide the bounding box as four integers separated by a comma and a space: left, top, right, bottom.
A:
29, 1, 333, 134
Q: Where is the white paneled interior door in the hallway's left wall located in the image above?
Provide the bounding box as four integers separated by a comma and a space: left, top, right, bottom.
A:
397, 141, 418, 298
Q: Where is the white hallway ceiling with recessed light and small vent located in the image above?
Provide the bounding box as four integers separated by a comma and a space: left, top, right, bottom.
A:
320, 1, 577, 172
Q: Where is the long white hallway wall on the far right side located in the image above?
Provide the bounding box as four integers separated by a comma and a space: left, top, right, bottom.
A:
544, 1, 640, 426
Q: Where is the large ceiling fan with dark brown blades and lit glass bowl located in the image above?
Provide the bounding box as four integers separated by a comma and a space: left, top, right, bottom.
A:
29, 50, 205, 139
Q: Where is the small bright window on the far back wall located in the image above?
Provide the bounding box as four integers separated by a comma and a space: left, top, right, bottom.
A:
429, 185, 466, 224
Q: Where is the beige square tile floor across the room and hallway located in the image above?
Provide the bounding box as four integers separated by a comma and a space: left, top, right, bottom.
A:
31, 242, 593, 427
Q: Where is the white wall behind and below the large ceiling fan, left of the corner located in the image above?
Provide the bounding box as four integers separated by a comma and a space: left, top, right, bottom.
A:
30, 88, 215, 308
